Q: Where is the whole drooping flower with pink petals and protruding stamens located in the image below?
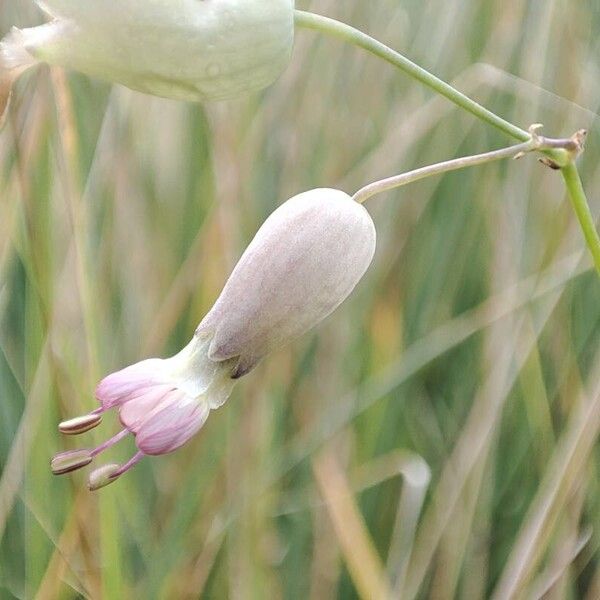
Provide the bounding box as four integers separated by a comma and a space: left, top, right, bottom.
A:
52, 189, 376, 489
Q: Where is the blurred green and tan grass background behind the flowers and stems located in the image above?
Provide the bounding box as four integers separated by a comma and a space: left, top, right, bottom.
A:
0, 0, 600, 600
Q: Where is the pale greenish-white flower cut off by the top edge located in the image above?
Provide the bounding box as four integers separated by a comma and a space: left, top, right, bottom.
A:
0, 0, 294, 125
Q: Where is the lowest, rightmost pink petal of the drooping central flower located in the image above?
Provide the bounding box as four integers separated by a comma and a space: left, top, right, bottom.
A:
135, 394, 210, 455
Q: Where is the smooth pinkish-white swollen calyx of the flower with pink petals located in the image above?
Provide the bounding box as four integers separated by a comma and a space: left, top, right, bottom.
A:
196, 189, 376, 377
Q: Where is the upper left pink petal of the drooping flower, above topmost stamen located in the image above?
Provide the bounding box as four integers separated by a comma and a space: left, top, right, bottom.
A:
96, 358, 166, 410
